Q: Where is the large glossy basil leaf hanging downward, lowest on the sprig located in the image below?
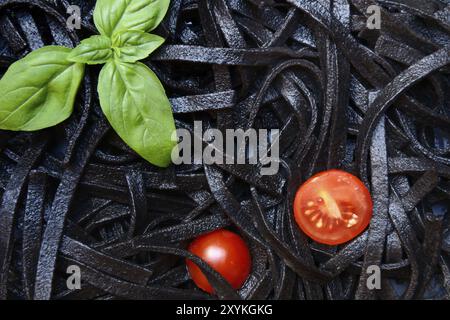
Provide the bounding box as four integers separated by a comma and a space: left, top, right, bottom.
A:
98, 60, 176, 167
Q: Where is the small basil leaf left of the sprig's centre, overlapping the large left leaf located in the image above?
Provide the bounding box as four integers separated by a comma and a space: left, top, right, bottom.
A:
67, 36, 112, 64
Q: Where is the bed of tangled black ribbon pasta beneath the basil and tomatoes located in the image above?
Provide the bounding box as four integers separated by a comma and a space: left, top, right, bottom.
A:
0, 0, 450, 300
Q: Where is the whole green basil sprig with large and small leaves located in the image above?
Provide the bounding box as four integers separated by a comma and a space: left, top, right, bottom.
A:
0, 0, 176, 167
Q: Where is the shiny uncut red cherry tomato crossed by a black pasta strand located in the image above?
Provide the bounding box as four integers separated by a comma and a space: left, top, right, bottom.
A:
186, 229, 251, 293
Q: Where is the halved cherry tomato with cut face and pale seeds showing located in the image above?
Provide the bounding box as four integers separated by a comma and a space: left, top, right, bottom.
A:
294, 170, 373, 245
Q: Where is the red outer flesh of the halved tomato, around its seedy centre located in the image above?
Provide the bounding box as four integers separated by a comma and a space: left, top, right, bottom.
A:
294, 169, 373, 245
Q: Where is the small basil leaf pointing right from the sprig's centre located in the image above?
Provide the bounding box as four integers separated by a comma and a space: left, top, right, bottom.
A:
113, 30, 165, 62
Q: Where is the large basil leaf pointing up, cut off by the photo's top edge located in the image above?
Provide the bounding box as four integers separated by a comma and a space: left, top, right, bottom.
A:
94, 0, 170, 37
